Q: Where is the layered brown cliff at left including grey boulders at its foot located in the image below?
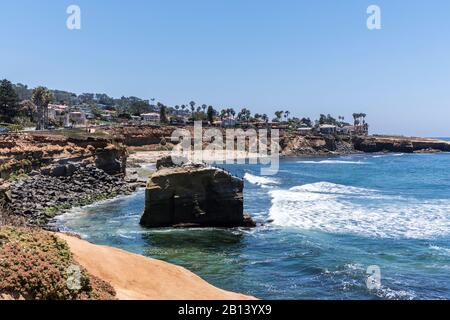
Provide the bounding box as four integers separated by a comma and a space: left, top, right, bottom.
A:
0, 132, 135, 226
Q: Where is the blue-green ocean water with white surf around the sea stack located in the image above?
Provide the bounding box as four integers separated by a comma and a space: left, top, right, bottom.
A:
57, 153, 450, 299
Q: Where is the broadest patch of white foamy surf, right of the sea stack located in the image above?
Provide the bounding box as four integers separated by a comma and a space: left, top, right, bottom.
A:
269, 182, 450, 239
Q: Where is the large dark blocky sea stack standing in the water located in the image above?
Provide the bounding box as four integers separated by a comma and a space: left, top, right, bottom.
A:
141, 159, 254, 228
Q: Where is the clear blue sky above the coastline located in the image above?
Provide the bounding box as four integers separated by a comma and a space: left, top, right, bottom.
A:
0, 0, 450, 136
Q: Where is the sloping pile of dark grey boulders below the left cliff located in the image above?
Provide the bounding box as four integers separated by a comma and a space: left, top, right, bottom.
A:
6, 163, 137, 226
